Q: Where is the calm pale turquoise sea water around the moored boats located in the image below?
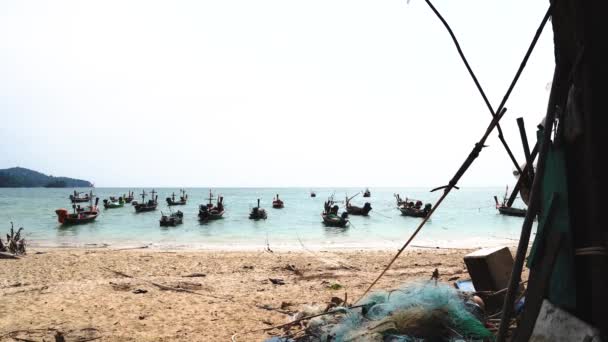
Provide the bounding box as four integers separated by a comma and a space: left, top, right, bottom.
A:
0, 188, 523, 249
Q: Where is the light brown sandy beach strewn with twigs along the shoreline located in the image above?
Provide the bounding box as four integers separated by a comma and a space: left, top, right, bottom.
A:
0, 248, 524, 341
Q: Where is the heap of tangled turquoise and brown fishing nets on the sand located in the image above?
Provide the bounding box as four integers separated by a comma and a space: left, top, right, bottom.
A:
266, 281, 493, 342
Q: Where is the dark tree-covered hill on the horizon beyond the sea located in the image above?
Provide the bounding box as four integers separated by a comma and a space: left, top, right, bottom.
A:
0, 167, 93, 188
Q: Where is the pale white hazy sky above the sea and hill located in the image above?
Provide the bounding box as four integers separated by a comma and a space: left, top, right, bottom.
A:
0, 0, 555, 187
